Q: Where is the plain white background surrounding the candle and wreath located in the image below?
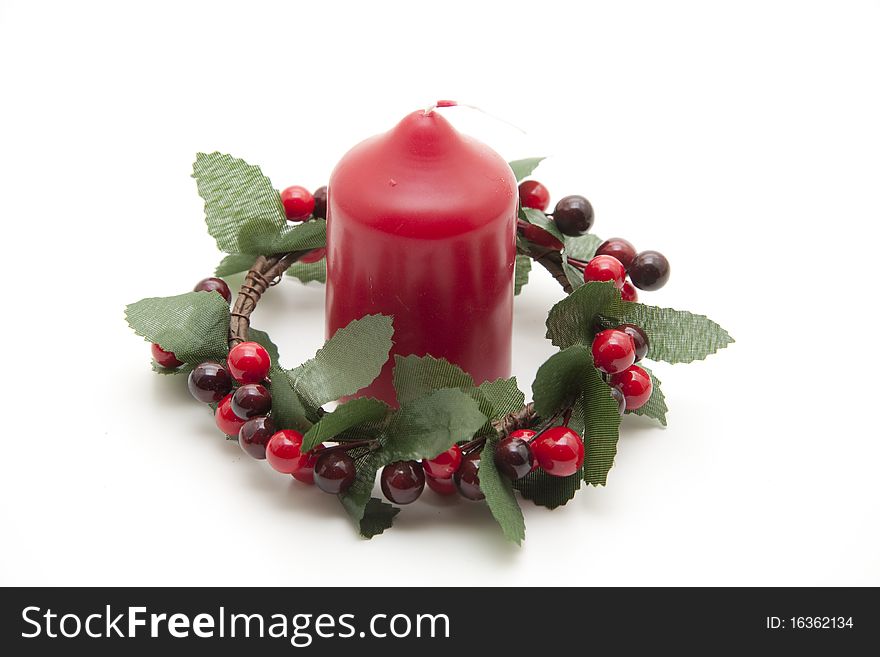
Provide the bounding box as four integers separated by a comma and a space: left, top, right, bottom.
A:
0, 0, 880, 585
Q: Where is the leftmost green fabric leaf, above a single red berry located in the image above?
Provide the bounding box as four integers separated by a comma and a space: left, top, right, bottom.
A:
125, 292, 229, 363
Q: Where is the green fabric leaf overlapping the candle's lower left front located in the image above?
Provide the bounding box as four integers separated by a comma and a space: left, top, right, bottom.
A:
290, 315, 394, 408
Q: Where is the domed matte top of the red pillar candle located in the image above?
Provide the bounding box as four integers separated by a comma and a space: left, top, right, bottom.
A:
329, 110, 517, 239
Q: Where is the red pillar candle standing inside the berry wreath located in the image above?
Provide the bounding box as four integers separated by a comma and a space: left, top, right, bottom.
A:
326, 110, 517, 404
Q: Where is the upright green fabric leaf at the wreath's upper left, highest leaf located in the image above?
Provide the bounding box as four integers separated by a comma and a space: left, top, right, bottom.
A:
193, 153, 287, 255
